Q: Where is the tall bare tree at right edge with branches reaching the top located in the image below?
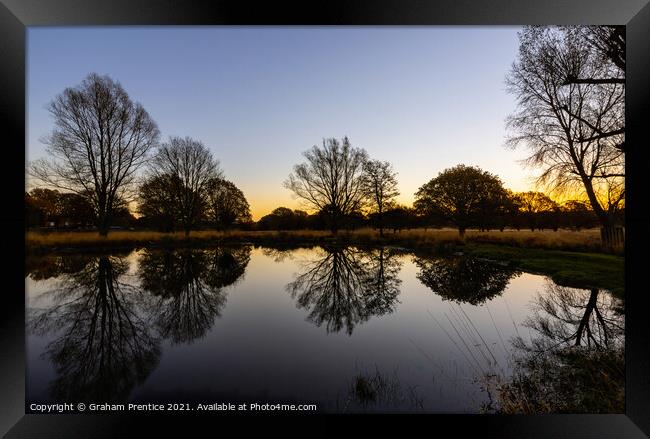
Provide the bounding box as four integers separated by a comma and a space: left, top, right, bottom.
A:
506, 26, 625, 246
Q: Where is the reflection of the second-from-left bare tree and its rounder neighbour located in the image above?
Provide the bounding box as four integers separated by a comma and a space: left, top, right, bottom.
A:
139, 246, 251, 343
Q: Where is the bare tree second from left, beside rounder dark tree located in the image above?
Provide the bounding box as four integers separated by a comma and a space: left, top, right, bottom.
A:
150, 137, 221, 236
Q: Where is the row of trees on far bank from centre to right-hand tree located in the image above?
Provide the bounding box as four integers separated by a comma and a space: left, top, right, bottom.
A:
280, 137, 612, 239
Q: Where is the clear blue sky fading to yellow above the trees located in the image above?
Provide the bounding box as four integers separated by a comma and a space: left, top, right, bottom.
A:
26, 26, 534, 220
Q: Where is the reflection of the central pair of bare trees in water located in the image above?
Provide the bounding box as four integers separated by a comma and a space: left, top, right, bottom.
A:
287, 247, 402, 335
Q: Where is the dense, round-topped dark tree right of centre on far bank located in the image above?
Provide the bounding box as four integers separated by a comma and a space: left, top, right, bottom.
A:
414, 165, 508, 239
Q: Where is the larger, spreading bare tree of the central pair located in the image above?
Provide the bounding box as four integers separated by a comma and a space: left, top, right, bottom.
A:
284, 137, 368, 233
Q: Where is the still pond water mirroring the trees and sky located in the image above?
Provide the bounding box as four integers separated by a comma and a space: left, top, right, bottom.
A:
25, 245, 623, 413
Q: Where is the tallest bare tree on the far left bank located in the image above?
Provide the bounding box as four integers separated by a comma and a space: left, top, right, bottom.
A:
29, 73, 159, 236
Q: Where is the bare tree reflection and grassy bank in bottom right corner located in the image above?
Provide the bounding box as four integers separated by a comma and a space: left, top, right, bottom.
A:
486, 281, 625, 413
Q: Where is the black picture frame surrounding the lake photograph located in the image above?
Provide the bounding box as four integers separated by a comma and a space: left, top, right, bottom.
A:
0, 0, 650, 439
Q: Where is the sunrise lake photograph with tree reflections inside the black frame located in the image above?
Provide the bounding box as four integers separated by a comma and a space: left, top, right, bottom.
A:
24, 24, 624, 416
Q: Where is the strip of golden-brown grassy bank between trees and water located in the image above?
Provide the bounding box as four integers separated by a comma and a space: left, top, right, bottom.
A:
25, 229, 625, 299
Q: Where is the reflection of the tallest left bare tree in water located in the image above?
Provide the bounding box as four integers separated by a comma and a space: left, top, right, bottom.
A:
28, 256, 160, 402
